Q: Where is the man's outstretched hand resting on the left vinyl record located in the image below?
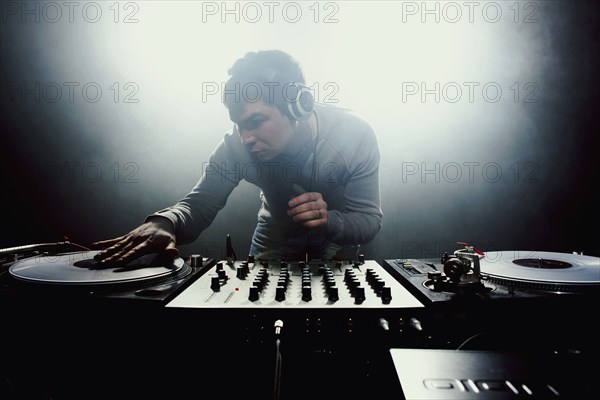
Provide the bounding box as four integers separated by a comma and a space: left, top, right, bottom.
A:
92, 217, 179, 263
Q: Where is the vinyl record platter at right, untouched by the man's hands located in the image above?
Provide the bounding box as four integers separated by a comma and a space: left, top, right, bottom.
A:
480, 250, 600, 291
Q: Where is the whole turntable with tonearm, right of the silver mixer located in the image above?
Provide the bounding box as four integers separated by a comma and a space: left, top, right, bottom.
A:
385, 245, 600, 304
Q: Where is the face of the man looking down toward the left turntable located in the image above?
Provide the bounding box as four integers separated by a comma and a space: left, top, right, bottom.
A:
230, 101, 294, 161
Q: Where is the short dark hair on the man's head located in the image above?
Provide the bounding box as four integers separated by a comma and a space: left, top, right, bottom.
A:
223, 50, 305, 116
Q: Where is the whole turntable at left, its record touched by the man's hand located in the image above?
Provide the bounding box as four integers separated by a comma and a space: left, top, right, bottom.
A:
0, 245, 214, 305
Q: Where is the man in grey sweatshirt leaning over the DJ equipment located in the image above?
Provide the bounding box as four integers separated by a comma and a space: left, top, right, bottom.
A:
95, 50, 383, 262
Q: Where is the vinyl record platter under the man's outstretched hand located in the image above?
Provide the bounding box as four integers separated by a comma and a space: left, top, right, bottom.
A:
9, 250, 185, 286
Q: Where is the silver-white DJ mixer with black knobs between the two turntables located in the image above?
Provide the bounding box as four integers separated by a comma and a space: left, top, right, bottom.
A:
167, 257, 423, 309
